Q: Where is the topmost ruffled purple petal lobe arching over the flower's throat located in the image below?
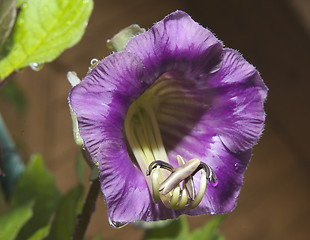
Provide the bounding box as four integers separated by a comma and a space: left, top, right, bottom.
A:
125, 11, 222, 80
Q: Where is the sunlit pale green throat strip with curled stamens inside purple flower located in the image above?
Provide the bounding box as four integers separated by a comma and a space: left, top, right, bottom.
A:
124, 78, 216, 209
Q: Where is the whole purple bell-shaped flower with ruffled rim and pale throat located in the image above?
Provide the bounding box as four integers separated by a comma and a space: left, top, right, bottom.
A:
69, 11, 267, 225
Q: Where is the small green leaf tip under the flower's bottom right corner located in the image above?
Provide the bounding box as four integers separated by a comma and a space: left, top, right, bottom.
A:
188, 215, 224, 240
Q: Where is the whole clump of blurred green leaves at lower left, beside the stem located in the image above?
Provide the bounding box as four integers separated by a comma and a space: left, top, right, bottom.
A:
0, 151, 84, 240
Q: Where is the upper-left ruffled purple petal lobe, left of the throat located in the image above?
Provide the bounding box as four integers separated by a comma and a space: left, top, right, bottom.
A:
69, 52, 146, 161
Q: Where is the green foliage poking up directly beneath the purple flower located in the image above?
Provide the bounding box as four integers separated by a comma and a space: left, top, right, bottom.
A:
144, 215, 224, 240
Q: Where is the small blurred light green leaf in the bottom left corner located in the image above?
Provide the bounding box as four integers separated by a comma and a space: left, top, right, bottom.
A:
0, 204, 32, 240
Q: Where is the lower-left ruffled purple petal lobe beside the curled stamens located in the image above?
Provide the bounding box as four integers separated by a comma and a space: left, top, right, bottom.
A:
99, 141, 183, 222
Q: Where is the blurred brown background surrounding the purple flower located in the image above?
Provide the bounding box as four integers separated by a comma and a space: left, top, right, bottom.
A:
0, 0, 310, 240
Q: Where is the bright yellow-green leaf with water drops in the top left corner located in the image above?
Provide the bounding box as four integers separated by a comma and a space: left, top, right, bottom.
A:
0, 0, 93, 79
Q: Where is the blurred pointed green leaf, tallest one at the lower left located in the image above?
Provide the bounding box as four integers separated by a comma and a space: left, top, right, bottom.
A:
11, 155, 60, 240
